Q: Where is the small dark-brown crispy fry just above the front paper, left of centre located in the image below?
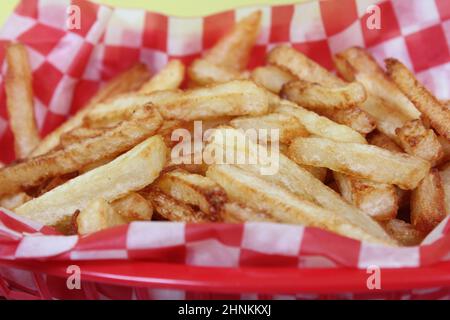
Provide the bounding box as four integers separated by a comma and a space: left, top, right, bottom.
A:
147, 190, 212, 223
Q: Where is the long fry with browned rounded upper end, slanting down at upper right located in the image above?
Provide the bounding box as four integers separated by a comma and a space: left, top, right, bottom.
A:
334, 47, 420, 121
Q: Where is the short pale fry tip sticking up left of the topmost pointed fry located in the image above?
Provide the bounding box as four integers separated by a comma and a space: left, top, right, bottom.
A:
138, 60, 185, 94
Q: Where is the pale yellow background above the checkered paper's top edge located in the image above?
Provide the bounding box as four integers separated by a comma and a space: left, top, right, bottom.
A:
0, 0, 305, 26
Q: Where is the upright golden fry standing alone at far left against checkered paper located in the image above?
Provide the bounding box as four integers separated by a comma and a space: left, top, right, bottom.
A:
5, 44, 40, 158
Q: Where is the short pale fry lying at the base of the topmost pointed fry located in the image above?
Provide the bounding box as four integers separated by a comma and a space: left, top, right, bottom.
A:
188, 59, 248, 86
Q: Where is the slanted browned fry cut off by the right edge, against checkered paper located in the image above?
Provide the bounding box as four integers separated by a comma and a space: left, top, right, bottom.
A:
386, 59, 450, 140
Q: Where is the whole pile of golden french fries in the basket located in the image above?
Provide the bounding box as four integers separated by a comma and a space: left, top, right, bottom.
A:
0, 12, 450, 245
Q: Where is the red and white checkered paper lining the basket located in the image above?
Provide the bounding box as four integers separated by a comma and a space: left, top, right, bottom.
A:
0, 0, 450, 297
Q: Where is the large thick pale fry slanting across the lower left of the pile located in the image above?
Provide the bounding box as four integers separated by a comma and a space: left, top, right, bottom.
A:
15, 136, 167, 226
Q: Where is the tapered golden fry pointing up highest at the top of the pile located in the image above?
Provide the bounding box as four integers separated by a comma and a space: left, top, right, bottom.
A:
203, 11, 262, 71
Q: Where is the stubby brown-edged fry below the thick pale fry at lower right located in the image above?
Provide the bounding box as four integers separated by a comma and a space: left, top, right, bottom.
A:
334, 172, 398, 221
